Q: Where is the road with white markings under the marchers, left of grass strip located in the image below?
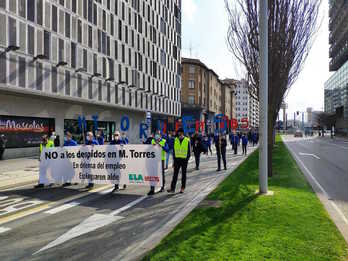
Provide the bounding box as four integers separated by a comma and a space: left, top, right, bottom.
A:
0, 145, 251, 260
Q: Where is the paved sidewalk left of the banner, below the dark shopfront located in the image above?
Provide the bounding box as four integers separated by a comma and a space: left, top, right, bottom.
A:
0, 158, 39, 189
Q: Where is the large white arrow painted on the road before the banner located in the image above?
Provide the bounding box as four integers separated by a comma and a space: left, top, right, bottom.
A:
33, 196, 147, 255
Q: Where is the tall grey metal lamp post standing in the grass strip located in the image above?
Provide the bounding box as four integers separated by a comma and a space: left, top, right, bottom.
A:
259, 0, 268, 194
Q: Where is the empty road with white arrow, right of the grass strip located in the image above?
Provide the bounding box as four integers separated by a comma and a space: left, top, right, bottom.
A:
283, 136, 348, 240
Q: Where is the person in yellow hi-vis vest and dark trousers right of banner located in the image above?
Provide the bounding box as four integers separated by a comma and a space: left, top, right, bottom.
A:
168, 128, 191, 193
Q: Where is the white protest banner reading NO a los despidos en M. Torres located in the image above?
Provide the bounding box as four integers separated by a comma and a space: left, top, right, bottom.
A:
40, 145, 162, 187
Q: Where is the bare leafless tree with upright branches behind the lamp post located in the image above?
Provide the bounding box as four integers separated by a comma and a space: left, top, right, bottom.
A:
225, 0, 321, 176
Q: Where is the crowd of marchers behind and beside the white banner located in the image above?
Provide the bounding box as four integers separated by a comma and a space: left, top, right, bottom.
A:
35, 128, 259, 195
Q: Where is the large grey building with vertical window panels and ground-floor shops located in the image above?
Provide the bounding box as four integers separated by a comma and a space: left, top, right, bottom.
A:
0, 0, 181, 158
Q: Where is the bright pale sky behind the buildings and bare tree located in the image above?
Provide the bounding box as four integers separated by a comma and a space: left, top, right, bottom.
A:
182, 0, 331, 119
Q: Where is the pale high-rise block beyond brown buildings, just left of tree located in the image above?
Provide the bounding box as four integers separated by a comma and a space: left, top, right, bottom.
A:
236, 80, 259, 129
